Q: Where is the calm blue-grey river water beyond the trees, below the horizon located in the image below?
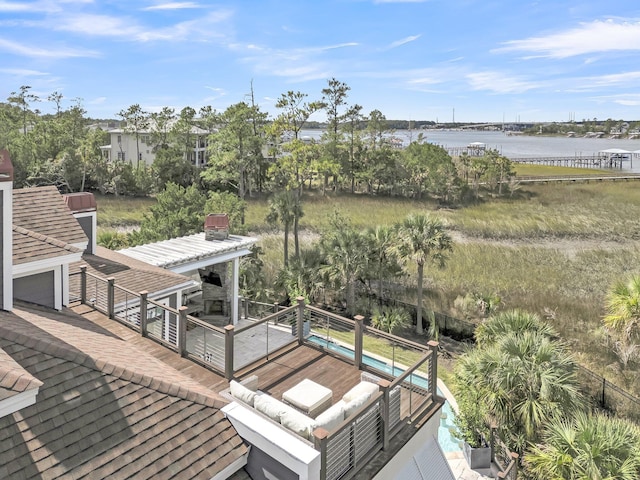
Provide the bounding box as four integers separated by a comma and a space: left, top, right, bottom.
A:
302, 130, 640, 172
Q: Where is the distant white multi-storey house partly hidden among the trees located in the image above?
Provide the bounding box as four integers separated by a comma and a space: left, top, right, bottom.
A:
100, 126, 209, 167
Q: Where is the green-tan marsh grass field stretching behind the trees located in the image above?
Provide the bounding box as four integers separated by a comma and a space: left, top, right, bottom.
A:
97, 172, 640, 394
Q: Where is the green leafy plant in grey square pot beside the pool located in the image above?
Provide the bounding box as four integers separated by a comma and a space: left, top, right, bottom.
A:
454, 398, 491, 469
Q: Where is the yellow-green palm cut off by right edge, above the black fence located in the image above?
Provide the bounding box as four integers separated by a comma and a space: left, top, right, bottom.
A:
604, 275, 640, 345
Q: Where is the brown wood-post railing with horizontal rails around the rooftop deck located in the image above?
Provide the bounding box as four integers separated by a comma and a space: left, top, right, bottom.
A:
79, 267, 438, 480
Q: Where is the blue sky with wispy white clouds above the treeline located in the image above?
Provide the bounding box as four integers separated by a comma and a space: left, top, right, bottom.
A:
0, 0, 640, 122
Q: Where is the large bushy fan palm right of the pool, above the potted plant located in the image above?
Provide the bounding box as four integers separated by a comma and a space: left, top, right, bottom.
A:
455, 324, 584, 452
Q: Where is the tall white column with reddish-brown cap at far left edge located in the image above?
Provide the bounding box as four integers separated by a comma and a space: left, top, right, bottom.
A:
0, 150, 13, 311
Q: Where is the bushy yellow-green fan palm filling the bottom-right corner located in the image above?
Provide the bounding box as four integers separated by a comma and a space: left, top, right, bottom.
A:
524, 412, 640, 480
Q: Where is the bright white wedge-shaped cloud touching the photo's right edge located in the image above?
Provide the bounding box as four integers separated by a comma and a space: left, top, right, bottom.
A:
494, 19, 640, 59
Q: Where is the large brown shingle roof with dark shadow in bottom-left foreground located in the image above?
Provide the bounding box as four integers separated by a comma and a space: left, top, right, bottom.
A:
0, 305, 247, 480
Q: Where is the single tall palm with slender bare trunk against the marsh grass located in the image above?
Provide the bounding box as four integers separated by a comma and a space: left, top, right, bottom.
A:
390, 214, 453, 335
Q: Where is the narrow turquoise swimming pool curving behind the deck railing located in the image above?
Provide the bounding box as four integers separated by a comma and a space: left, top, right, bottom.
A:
307, 335, 462, 453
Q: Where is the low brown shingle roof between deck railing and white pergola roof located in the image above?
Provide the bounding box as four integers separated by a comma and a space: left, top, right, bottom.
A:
69, 246, 195, 303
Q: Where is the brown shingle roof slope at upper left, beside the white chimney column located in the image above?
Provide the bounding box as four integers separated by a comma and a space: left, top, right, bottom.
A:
13, 186, 88, 248
